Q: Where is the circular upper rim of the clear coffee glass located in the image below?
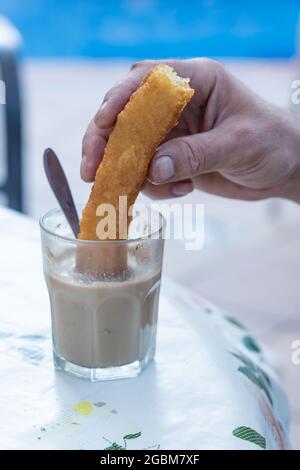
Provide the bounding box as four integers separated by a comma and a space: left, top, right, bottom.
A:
39, 204, 166, 245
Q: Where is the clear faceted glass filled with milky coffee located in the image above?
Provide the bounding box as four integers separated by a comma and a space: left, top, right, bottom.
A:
40, 207, 164, 381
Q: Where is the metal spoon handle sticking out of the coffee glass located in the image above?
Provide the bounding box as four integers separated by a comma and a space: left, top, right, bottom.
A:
44, 148, 79, 238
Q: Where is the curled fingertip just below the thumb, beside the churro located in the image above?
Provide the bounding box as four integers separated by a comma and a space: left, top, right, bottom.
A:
143, 180, 194, 199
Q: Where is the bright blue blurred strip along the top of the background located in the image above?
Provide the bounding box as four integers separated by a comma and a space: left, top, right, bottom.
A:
0, 0, 300, 59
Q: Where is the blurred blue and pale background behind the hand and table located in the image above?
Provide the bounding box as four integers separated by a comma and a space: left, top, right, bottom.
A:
0, 0, 300, 448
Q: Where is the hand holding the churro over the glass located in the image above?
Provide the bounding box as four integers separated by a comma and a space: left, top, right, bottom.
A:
81, 59, 300, 202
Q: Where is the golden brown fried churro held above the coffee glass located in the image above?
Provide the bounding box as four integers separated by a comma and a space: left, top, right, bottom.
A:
79, 65, 194, 240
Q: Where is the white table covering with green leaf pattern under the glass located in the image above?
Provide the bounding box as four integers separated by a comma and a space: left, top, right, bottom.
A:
0, 208, 289, 449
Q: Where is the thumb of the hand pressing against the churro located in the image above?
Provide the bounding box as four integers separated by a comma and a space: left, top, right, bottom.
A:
148, 128, 234, 184
